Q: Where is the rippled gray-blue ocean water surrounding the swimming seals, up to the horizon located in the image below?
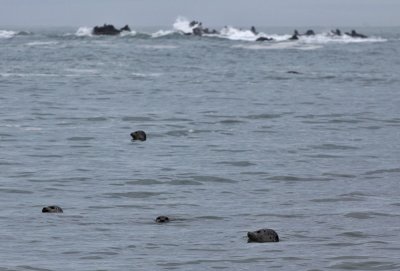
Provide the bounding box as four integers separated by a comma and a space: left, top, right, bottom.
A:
0, 20, 400, 271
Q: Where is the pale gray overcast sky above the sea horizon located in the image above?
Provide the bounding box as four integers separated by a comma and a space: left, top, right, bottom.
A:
0, 0, 400, 29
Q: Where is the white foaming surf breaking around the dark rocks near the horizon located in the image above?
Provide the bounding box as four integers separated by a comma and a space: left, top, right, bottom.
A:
0, 16, 387, 45
